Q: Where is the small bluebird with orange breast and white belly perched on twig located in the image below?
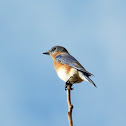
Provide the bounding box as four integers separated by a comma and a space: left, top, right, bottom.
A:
43, 46, 97, 90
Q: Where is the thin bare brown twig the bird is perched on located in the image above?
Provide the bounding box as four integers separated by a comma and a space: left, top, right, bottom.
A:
67, 85, 73, 126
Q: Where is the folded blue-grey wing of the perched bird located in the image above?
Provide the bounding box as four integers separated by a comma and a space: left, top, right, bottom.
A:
55, 54, 93, 76
